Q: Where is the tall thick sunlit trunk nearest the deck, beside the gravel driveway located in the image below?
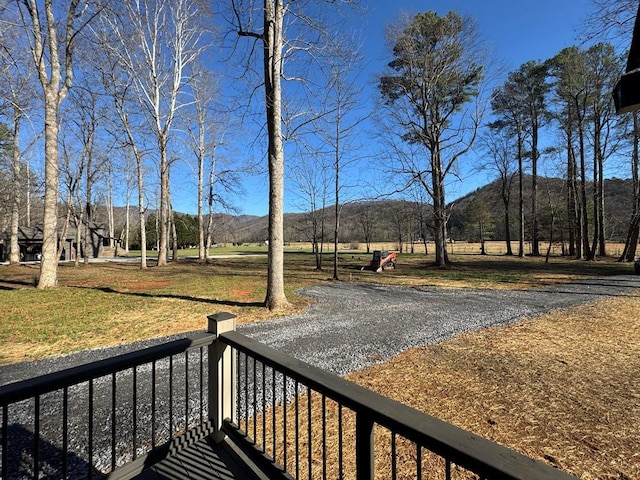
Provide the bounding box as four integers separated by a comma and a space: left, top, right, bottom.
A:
263, 0, 288, 310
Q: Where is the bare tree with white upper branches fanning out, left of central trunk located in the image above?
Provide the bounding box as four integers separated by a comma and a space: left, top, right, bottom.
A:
109, 0, 203, 265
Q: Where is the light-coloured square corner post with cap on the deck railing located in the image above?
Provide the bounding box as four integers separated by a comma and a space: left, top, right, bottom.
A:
207, 312, 236, 442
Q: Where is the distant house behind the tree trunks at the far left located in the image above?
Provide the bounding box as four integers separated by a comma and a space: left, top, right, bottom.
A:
0, 225, 113, 262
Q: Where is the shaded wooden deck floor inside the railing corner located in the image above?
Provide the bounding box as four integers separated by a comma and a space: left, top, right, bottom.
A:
134, 436, 269, 480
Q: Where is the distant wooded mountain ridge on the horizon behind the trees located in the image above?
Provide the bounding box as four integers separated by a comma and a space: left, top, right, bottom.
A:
100, 176, 633, 243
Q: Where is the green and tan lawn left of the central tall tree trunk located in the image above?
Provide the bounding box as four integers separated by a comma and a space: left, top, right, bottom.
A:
0, 261, 318, 365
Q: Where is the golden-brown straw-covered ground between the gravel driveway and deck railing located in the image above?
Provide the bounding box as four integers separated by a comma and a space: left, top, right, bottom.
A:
247, 297, 640, 480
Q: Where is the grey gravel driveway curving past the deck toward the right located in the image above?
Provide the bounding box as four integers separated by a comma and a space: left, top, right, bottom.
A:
0, 275, 640, 385
